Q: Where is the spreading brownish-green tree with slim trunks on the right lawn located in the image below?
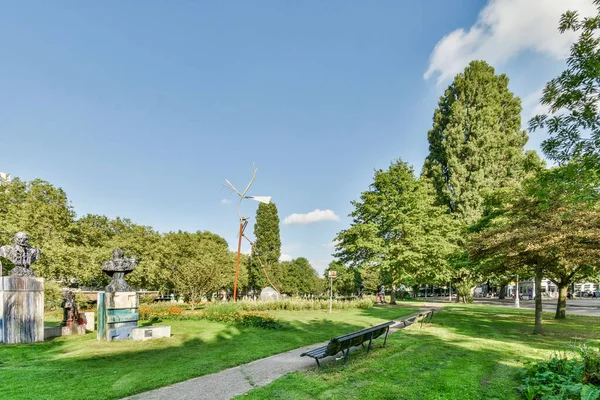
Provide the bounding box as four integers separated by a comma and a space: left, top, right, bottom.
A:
468, 164, 600, 323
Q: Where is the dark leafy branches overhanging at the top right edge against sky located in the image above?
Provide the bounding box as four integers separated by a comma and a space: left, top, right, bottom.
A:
529, 0, 600, 164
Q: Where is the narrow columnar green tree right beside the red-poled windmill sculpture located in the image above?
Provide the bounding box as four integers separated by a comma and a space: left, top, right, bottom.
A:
248, 203, 281, 289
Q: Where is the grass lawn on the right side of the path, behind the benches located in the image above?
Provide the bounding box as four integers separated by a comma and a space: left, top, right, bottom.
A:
239, 305, 600, 400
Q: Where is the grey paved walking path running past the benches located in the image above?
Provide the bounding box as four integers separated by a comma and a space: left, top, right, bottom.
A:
128, 305, 440, 400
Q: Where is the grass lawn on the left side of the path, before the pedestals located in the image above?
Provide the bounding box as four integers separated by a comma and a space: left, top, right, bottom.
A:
0, 307, 416, 399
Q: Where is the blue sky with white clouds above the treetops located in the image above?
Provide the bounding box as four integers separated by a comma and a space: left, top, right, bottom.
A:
0, 0, 593, 272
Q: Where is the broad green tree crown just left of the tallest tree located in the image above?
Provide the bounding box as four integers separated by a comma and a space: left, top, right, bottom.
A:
335, 161, 460, 286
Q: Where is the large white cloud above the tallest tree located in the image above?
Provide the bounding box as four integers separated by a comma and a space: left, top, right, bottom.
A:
423, 0, 596, 84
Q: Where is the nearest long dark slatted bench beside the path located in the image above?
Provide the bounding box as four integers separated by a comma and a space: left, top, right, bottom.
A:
300, 321, 395, 367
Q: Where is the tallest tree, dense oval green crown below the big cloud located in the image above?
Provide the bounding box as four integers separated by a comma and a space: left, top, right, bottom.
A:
423, 61, 527, 223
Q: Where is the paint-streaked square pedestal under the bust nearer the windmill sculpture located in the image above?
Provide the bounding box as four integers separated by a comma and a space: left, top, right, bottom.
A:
98, 292, 139, 340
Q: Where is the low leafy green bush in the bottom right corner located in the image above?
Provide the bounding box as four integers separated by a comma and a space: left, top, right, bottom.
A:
517, 346, 600, 400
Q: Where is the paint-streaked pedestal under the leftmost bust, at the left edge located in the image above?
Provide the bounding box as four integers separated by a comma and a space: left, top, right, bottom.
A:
0, 276, 44, 344
